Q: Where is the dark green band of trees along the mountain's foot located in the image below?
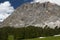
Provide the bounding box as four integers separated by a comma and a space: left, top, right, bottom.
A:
0, 25, 60, 40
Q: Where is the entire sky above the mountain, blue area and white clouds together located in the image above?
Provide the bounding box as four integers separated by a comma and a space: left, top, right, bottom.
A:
0, 0, 60, 22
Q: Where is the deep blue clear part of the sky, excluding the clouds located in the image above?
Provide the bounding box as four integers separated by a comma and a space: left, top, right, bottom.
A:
0, 0, 33, 9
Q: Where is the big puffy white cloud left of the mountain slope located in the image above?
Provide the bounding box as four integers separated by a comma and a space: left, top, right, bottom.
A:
0, 1, 14, 22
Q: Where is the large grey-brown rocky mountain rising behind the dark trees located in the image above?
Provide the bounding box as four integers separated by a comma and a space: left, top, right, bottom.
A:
1, 2, 60, 27
